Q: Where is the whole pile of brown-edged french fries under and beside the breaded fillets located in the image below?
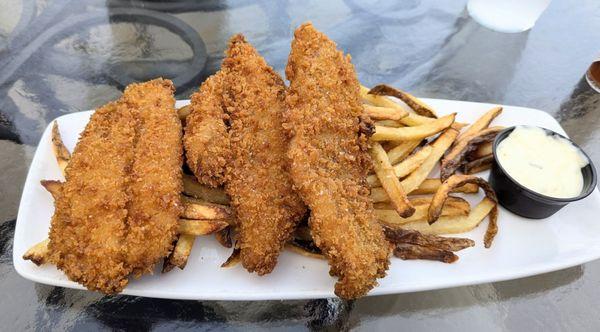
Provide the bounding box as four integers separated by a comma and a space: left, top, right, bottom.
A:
23, 85, 502, 273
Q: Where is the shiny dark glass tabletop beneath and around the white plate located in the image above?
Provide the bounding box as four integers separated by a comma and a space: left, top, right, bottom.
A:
0, 0, 600, 331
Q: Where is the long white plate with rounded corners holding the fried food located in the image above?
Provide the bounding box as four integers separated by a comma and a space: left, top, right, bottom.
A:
13, 99, 600, 300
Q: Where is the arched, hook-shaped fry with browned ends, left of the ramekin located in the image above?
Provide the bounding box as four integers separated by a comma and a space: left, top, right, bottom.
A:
427, 175, 498, 224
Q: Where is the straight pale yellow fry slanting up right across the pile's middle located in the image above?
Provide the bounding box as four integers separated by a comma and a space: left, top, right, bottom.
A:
401, 128, 458, 193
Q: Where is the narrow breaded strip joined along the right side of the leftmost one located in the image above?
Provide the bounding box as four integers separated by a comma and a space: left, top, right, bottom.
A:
123, 79, 183, 276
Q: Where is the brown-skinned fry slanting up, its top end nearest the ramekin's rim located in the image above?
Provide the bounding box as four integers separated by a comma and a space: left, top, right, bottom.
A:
440, 127, 504, 181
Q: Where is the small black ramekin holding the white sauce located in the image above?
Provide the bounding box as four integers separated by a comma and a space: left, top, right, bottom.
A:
489, 127, 597, 219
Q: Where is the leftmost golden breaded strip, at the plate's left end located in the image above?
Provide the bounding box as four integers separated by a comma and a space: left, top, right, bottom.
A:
49, 102, 136, 293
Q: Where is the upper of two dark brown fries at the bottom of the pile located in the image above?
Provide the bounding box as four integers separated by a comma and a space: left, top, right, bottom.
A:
383, 227, 475, 251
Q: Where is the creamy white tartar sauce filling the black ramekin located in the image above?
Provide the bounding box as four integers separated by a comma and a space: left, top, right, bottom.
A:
496, 126, 588, 198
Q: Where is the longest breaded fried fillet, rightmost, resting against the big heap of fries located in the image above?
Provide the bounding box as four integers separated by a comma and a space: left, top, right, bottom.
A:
284, 23, 390, 299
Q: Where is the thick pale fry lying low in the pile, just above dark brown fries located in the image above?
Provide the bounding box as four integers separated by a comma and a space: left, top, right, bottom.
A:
402, 197, 496, 235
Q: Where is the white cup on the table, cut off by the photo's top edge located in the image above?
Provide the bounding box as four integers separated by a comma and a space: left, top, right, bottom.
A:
467, 0, 551, 33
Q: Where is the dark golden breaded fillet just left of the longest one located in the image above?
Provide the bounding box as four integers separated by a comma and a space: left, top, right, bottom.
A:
223, 35, 306, 275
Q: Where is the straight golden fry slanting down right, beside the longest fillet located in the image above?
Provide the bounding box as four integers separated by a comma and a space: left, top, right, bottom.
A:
369, 143, 415, 218
